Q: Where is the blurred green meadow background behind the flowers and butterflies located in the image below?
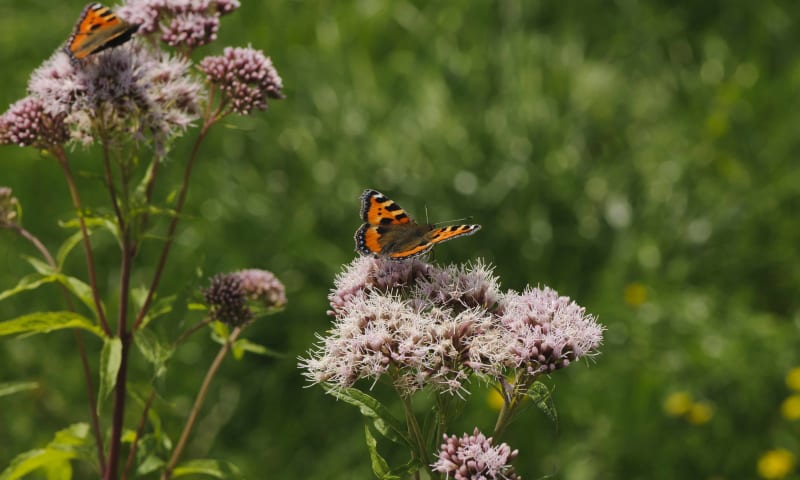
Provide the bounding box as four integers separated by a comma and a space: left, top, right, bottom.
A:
0, 0, 800, 479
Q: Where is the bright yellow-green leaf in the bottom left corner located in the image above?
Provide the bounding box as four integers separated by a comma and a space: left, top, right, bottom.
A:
0, 423, 94, 480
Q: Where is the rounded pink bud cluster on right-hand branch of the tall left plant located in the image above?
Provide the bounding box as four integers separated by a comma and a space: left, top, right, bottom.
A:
199, 47, 283, 115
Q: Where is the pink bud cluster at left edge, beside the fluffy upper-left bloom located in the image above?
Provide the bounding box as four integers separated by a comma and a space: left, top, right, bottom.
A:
0, 96, 69, 147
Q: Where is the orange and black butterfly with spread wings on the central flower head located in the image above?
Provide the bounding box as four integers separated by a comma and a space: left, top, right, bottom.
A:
355, 189, 481, 260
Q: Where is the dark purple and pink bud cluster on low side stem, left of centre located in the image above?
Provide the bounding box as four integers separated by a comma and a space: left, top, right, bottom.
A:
203, 269, 286, 326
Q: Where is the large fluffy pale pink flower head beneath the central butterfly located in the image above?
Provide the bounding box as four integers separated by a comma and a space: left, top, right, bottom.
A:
300, 257, 603, 395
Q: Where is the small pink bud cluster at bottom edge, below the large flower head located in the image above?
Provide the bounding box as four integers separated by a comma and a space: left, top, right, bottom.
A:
432, 427, 522, 480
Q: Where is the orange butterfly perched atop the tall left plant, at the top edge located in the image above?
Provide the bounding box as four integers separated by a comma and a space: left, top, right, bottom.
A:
64, 3, 139, 60
